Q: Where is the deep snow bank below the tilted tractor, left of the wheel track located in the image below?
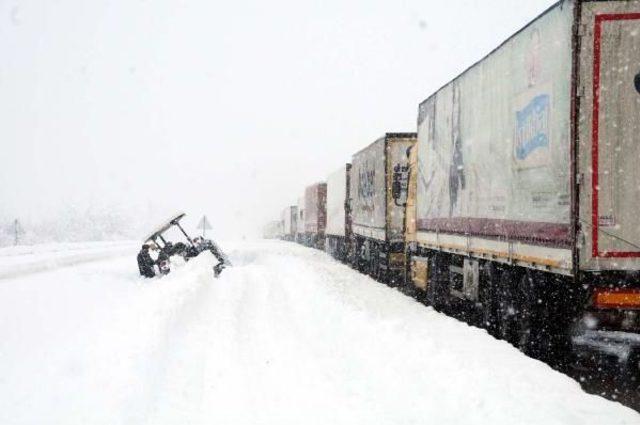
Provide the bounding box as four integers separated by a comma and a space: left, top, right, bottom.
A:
0, 248, 215, 424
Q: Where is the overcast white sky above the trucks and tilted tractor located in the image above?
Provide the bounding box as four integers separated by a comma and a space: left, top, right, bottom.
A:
0, 0, 555, 237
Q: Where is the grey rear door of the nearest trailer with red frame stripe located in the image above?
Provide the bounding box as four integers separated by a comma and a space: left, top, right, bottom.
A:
577, 1, 640, 270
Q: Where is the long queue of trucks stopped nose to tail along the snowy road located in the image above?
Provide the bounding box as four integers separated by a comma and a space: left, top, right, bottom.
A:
265, 0, 640, 388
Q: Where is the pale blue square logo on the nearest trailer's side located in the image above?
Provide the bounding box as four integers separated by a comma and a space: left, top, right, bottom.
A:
515, 94, 550, 161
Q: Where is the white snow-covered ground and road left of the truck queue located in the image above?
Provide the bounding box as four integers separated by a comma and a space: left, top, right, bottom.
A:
0, 242, 640, 425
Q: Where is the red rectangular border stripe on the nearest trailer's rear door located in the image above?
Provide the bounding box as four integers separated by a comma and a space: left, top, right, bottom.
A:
591, 13, 640, 258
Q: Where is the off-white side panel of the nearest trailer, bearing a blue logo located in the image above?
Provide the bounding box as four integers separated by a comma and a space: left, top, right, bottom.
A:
417, 1, 573, 270
